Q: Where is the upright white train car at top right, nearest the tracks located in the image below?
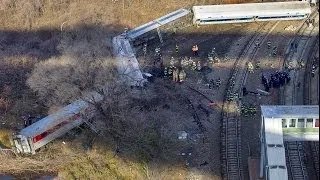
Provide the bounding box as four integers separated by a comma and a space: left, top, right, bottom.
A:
192, 1, 311, 25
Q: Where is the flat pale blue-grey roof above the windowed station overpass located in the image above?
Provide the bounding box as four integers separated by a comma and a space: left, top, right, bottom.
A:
261, 105, 319, 118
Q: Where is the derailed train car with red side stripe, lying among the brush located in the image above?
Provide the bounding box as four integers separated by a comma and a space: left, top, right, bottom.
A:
12, 92, 103, 154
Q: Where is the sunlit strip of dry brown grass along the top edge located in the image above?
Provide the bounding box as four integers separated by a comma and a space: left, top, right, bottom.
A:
0, 0, 252, 30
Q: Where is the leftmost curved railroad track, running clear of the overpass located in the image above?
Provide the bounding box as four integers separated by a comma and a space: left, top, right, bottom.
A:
221, 22, 279, 180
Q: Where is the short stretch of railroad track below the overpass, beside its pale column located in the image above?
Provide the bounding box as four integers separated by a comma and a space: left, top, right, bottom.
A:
284, 141, 309, 180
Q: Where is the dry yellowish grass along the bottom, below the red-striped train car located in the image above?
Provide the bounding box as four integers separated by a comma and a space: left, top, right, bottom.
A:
0, 134, 187, 180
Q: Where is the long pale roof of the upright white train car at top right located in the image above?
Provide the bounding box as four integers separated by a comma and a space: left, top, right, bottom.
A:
193, 1, 311, 19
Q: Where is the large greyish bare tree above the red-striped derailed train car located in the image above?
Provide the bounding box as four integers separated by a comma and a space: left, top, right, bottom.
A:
27, 25, 116, 106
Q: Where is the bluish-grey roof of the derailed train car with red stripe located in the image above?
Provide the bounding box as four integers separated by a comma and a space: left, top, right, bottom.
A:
19, 92, 103, 137
